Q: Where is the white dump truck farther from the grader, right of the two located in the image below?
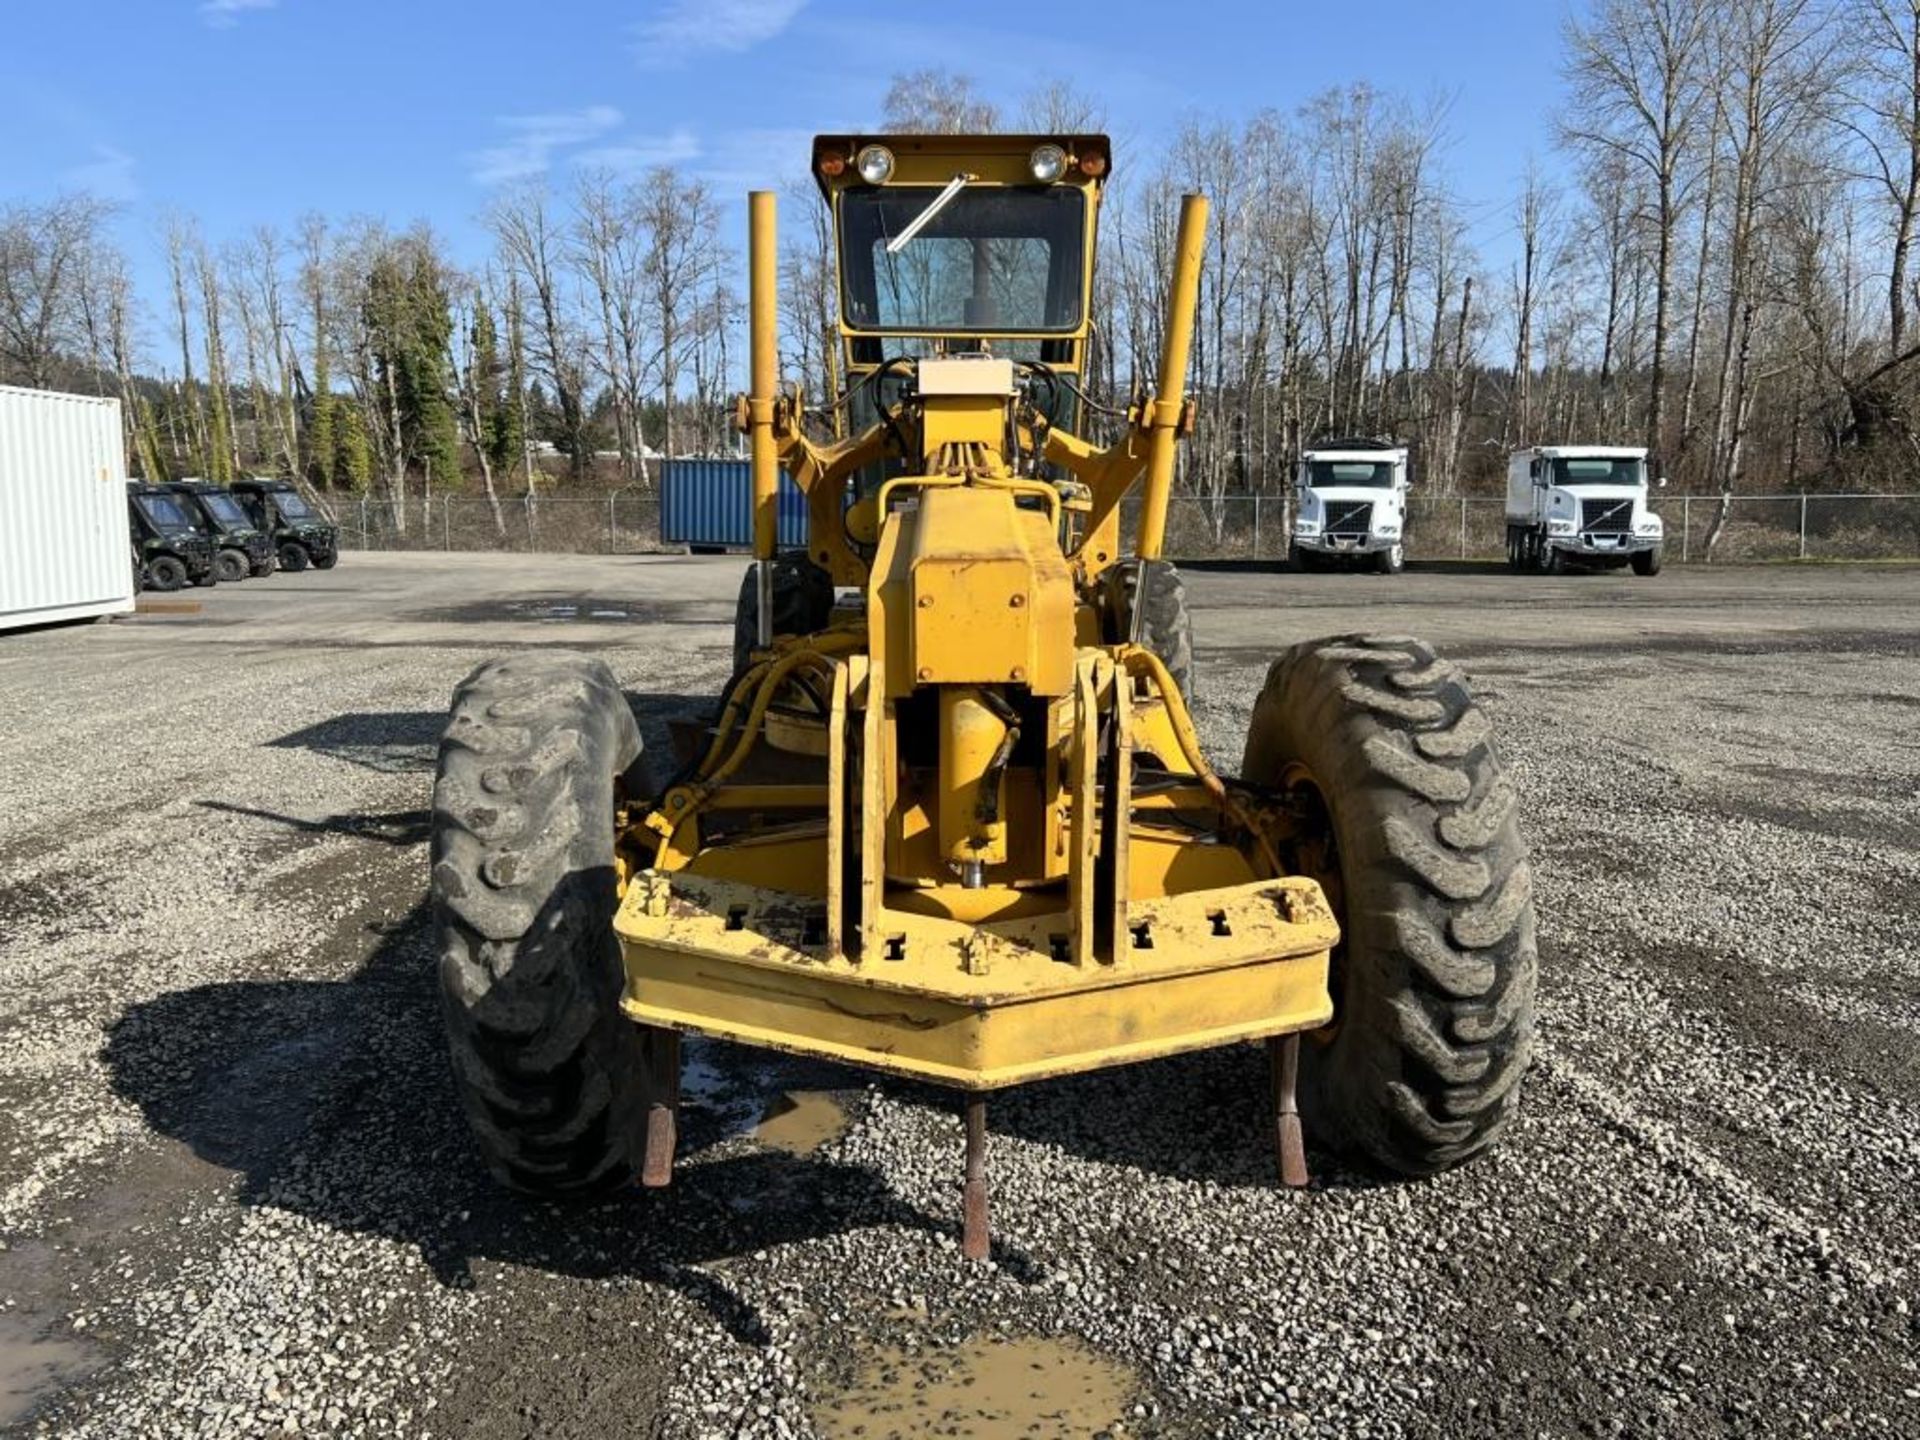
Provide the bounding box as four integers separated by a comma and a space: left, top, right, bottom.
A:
1507, 445, 1667, 574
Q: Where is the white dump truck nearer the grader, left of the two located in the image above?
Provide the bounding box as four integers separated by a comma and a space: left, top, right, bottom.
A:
1288, 440, 1411, 574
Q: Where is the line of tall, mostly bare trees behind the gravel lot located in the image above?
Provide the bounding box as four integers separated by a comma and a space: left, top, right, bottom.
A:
0, 0, 1920, 545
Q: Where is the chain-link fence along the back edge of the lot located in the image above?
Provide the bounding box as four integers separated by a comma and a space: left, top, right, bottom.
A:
334, 488, 1920, 563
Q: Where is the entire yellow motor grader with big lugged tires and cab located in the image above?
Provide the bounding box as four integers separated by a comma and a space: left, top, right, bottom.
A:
432, 134, 1536, 1256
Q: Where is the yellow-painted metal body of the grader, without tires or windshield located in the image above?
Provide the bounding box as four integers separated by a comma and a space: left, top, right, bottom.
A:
616, 136, 1338, 1089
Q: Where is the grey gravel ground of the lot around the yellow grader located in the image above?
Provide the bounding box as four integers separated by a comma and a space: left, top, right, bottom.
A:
0, 555, 1920, 1436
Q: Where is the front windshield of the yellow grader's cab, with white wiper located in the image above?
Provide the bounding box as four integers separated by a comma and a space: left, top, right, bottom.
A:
839, 184, 1087, 334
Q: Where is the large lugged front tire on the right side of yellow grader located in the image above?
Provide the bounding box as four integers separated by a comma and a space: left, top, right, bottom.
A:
1244, 636, 1538, 1175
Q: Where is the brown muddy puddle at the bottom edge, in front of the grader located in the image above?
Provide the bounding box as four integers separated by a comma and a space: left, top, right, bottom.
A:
814, 1336, 1139, 1440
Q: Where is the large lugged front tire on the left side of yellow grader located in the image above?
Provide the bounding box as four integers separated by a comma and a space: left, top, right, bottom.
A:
432, 651, 647, 1198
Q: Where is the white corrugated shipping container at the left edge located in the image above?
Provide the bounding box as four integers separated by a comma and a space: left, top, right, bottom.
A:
0, 386, 132, 630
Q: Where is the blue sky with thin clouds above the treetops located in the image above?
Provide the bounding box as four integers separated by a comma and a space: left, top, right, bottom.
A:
0, 0, 1565, 324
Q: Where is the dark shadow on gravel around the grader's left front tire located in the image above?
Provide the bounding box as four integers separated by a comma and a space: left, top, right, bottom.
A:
104, 902, 975, 1344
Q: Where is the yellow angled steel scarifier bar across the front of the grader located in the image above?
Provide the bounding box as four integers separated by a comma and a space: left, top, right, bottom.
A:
614, 876, 1338, 1089
